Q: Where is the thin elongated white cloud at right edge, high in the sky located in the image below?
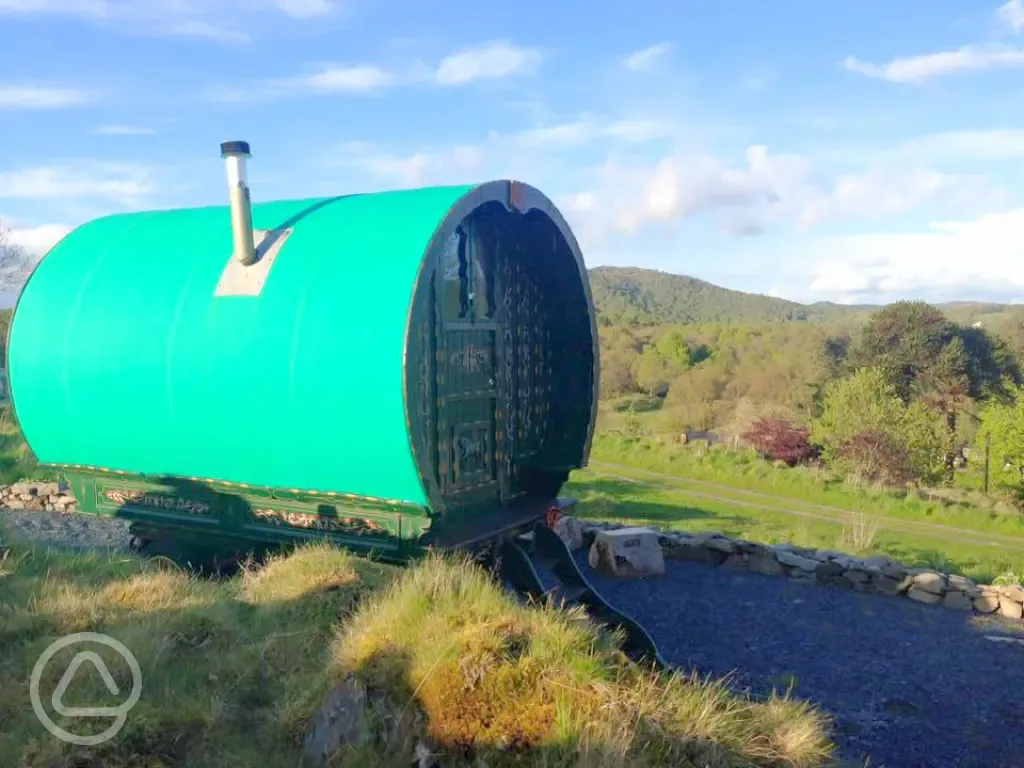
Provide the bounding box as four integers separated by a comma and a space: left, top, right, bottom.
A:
843, 45, 1024, 84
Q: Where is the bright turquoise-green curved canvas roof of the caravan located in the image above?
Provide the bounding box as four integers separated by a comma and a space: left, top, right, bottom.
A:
8, 181, 586, 505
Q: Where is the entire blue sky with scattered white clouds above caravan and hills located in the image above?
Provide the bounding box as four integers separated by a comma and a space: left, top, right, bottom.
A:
0, 0, 1024, 302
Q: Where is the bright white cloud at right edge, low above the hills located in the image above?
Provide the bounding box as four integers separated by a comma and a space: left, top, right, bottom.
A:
798, 208, 1024, 303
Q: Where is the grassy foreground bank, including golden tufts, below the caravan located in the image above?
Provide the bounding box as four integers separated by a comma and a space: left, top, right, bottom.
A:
0, 546, 833, 768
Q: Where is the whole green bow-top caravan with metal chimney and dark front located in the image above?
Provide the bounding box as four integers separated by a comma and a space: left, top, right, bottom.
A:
8, 142, 598, 556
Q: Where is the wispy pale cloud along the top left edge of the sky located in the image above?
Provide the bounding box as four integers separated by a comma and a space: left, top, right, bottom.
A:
0, 0, 337, 43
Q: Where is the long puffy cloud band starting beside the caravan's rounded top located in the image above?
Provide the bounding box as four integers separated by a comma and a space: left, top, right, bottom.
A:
552, 140, 1007, 253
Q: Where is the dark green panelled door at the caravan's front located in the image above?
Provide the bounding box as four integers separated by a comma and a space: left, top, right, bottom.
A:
437, 225, 501, 507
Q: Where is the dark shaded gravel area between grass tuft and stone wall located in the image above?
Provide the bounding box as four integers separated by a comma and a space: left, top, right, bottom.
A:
579, 553, 1024, 768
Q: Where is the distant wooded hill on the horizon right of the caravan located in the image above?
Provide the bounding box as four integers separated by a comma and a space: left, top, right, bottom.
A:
589, 266, 1024, 326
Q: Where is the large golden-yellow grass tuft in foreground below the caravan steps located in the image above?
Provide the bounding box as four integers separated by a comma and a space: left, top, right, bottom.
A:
323, 557, 833, 768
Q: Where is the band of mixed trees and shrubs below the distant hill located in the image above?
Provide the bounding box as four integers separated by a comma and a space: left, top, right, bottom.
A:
601, 301, 1024, 499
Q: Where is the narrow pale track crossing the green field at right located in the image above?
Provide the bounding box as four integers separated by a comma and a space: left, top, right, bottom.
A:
590, 461, 1024, 552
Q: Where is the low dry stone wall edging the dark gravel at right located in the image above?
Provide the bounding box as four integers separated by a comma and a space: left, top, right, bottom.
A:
581, 522, 1024, 621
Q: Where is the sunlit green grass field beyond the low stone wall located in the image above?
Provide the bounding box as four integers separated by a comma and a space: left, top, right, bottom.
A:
564, 435, 1024, 582
